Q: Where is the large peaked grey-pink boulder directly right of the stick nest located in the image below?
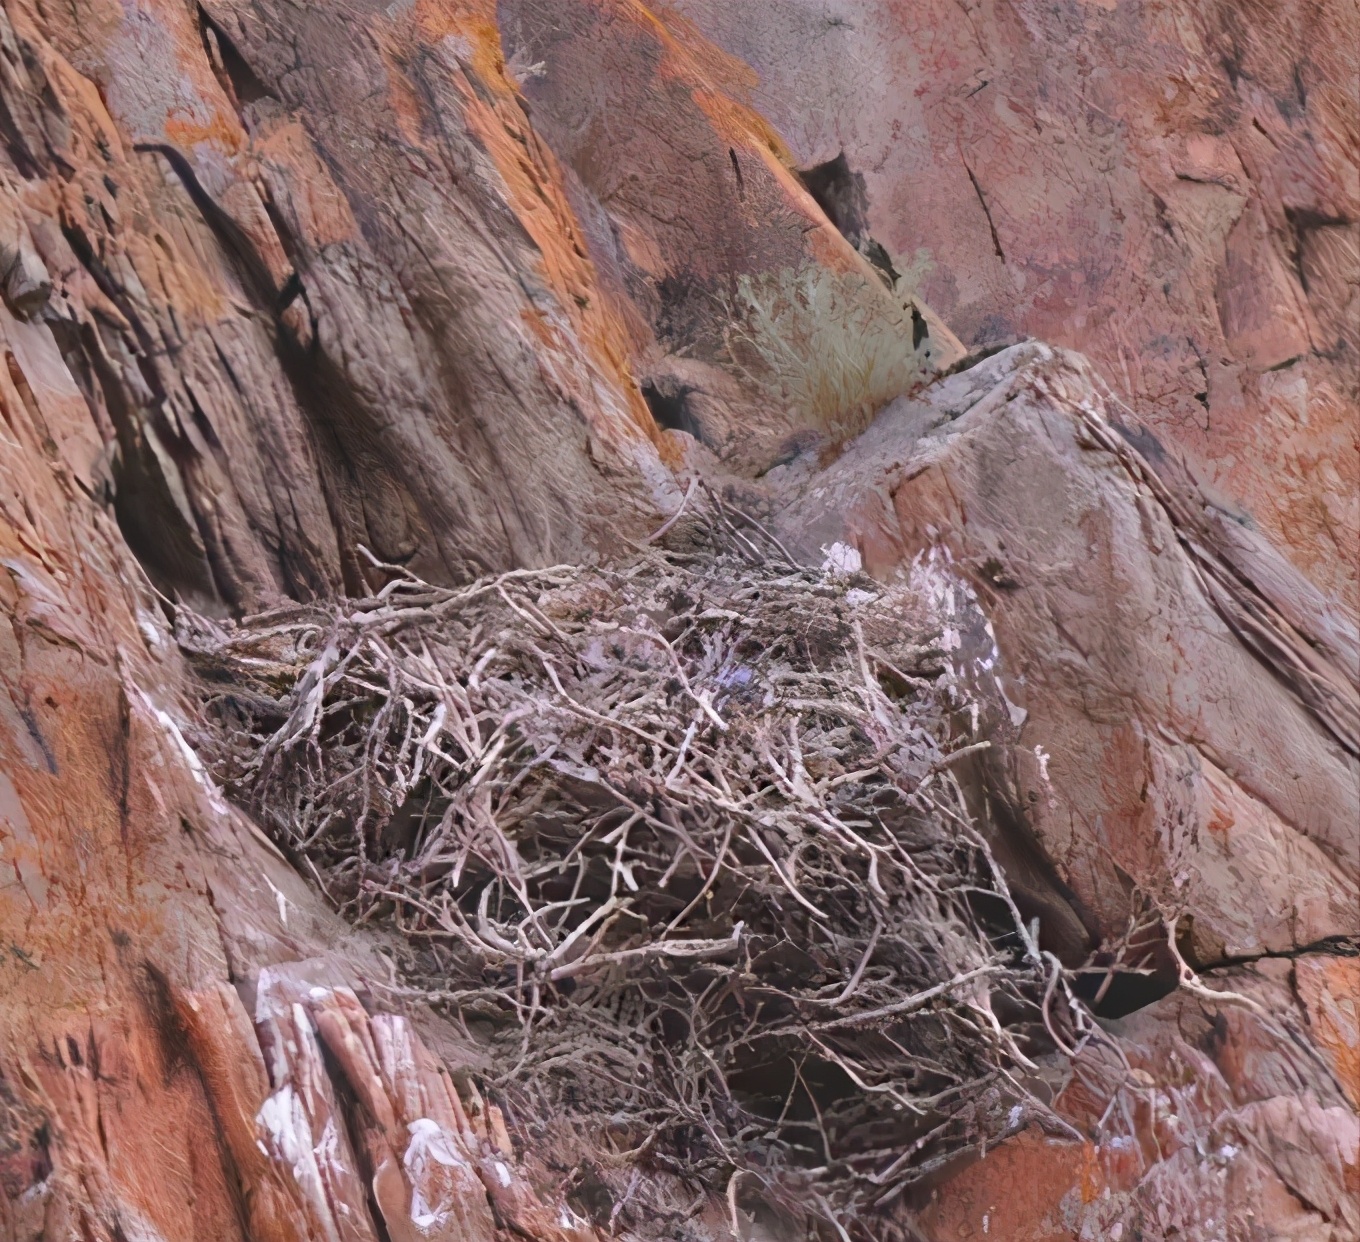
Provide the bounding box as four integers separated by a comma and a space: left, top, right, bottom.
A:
786, 346, 1360, 964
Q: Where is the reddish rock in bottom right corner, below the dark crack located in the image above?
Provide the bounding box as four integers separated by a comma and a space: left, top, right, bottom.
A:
919, 959, 1360, 1242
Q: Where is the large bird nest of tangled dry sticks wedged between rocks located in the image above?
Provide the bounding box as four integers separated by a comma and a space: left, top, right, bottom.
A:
178, 505, 1083, 1238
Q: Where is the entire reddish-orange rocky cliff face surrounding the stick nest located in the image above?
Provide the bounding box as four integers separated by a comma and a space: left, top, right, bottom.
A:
0, 0, 1360, 1242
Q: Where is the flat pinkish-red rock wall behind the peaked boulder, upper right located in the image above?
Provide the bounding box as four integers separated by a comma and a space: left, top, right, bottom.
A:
666, 0, 1360, 607
